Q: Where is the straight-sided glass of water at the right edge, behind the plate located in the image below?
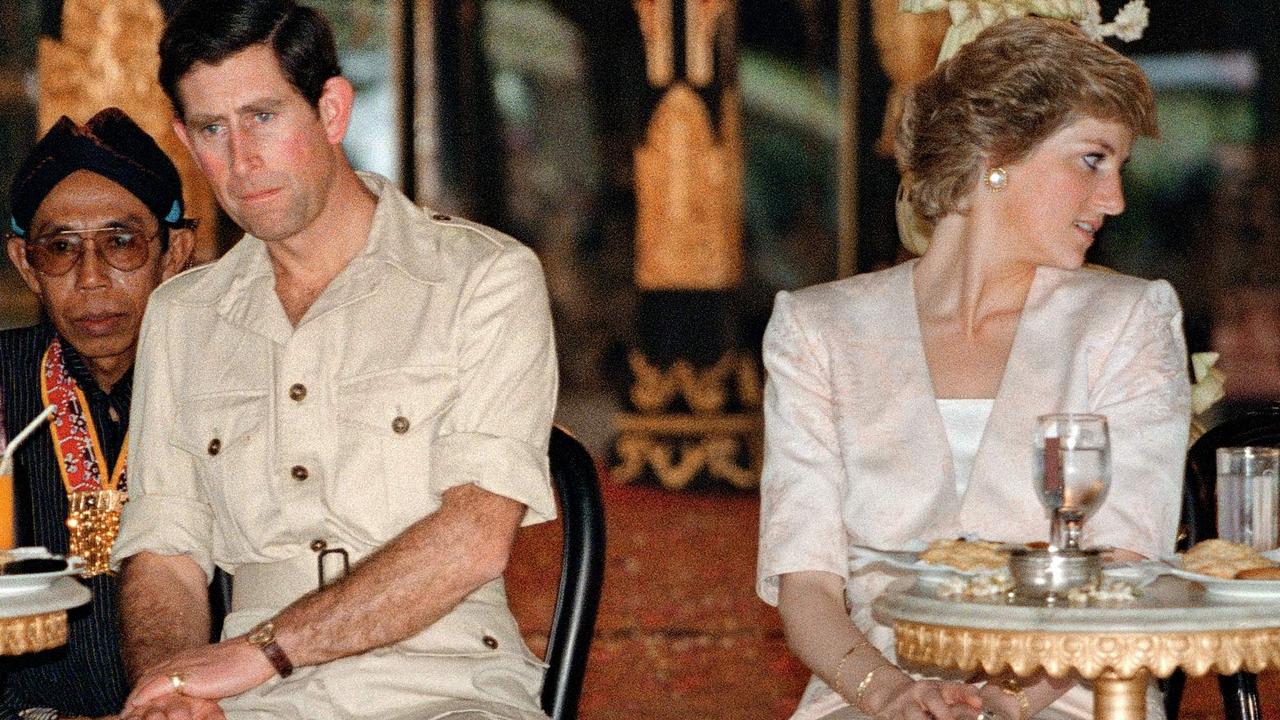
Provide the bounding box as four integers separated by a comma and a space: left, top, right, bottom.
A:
1217, 447, 1280, 552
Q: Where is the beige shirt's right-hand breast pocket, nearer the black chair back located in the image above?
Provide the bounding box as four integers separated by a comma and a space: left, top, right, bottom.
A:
334, 365, 457, 533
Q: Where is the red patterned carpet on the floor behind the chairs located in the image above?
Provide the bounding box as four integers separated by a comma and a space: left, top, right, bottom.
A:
507, 471, 1280, 720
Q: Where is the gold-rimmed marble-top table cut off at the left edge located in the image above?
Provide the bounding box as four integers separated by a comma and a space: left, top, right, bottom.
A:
0, 577, 93, 655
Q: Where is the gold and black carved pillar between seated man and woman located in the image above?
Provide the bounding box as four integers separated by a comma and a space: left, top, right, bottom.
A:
613, 0, 762, 488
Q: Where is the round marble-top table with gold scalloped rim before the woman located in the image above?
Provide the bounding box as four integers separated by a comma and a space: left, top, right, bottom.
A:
874, 577, 1280, 720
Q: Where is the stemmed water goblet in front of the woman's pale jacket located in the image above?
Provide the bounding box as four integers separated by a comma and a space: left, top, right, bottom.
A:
1033, 413, 1111, 550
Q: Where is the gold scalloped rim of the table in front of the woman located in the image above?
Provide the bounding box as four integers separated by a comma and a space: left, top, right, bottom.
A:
893, 621, 1280, 679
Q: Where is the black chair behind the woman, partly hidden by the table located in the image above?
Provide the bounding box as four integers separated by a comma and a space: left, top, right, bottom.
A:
1165, 404, 1280, 720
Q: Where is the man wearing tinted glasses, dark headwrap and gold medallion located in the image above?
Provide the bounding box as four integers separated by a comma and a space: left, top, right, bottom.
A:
0, 108, 193, 720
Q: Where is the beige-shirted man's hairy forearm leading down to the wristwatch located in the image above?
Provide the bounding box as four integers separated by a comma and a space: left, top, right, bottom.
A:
275, 486, 524, 665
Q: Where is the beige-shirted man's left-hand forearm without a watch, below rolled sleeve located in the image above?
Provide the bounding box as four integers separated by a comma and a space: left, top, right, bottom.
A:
120, 552, 210, 683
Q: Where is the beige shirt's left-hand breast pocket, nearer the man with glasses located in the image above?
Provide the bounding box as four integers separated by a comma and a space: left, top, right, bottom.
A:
169, 391, 274, 551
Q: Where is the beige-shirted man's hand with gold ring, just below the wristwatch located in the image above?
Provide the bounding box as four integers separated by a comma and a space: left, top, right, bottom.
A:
122, 638, 275, 707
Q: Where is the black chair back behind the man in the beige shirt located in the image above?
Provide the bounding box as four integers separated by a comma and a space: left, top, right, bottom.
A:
543, 427, 604, 720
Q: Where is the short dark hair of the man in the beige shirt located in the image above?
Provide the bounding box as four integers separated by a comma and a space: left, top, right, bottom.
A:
160, 0, 342, 118
